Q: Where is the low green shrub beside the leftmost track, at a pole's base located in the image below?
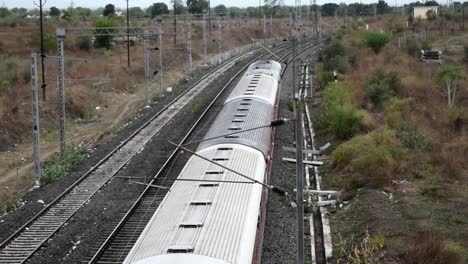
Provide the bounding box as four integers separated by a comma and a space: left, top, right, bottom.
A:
42, 146, 83, 184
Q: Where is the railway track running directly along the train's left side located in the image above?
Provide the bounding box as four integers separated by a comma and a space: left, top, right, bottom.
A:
89, 41, 314, 264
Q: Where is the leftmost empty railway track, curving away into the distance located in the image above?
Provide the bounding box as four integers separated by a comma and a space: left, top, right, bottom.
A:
0, 42, 286, 263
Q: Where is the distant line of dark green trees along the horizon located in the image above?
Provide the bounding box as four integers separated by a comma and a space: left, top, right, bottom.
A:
0, 0, 468, 21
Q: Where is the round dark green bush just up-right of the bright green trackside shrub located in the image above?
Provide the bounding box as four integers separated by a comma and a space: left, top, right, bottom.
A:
364, 69, 401, 109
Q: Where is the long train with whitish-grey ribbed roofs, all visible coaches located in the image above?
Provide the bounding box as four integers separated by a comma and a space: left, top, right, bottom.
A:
124, 60, 282, 264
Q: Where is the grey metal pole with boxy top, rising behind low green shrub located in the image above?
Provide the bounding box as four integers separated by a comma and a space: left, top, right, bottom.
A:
55, 28, 66, 157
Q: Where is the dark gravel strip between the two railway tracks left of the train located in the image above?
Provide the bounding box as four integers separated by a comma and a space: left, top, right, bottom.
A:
22, 52, 260, 263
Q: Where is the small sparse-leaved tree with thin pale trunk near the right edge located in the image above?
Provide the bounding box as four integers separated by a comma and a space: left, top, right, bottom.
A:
436, 66, 465, 107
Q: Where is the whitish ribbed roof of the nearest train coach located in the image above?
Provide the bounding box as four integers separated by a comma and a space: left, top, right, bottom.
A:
124, 144, 266, 264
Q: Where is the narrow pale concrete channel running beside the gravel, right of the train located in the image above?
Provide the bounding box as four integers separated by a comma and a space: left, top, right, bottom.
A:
299, 60, 332, 264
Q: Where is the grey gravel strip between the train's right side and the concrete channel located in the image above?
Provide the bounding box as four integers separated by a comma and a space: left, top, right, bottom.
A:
261, 46, 316, 264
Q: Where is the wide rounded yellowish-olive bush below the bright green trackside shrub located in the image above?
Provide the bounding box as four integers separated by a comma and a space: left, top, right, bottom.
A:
332, 128, 404, 188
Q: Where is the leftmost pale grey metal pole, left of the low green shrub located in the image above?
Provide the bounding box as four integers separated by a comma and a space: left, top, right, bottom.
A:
31, 53, 41, 188
